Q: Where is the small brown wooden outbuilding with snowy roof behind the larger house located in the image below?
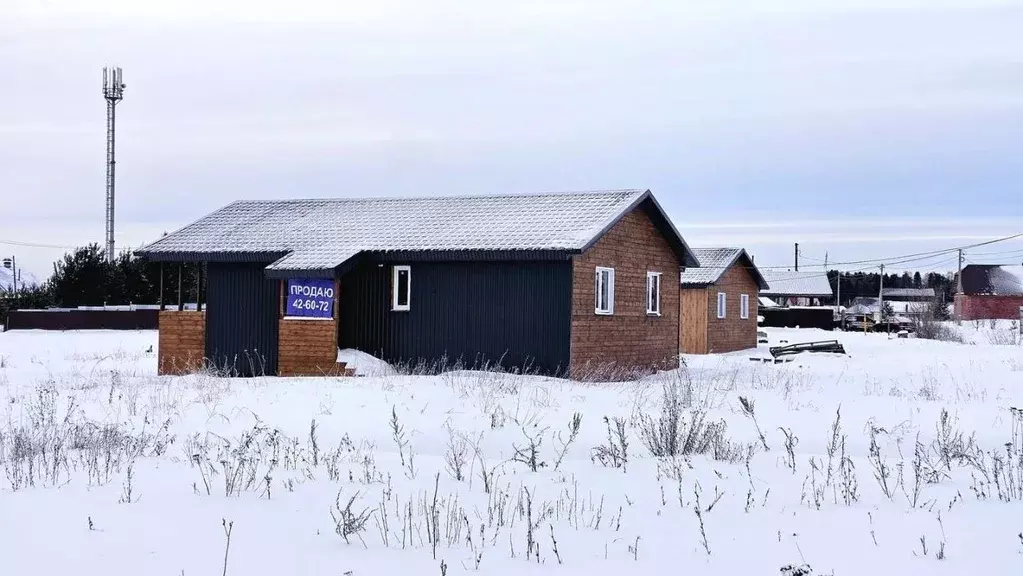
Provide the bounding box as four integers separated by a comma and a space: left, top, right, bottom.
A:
678, 248, 767, 354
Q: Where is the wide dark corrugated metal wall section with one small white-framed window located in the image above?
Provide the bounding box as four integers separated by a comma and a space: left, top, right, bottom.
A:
339, 261, 572, 373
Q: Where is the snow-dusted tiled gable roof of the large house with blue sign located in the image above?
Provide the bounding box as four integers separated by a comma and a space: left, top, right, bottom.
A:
139, 189, 699, 276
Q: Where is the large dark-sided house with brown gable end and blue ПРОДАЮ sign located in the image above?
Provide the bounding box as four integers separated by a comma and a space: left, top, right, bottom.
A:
140, 189, 699, 376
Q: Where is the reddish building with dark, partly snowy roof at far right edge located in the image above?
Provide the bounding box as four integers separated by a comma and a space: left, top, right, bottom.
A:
954, 264, 1023, 320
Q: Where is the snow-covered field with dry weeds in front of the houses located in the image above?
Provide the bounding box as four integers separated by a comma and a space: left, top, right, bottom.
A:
0, 324, 1023, 576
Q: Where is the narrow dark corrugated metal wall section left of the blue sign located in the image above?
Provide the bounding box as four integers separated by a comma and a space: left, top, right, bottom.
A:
206, 263, 280, 376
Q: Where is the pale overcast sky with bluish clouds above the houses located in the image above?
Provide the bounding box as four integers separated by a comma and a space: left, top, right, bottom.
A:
0, 0, 1023, 276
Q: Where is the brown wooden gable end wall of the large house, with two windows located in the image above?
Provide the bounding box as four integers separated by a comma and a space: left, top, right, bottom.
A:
570, 204, 681, 378
